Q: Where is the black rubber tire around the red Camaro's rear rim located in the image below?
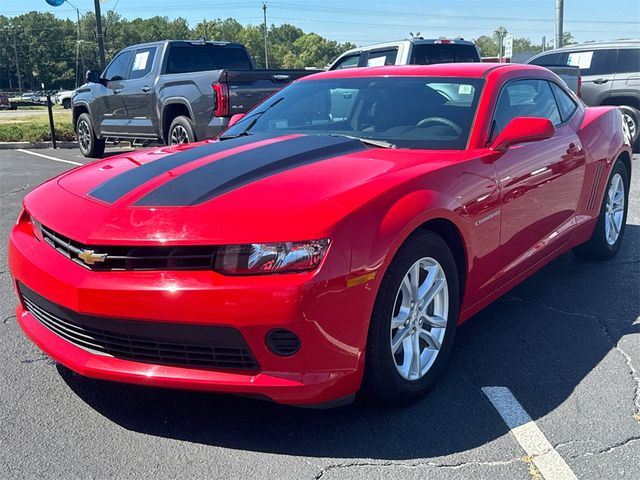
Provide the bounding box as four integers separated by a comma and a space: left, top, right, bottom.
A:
573, 159, 629, 260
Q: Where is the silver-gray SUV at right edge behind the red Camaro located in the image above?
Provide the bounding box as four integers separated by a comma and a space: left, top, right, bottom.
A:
528, 40, 640, 149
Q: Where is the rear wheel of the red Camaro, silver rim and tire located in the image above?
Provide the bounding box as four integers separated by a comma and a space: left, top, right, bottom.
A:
573, 159, 629, 260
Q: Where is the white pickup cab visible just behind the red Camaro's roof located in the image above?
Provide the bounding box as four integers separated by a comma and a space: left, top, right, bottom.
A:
329, 37, 480, 70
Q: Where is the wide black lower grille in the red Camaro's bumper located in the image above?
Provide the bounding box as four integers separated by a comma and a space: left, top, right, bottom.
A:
18, 283, 259, 371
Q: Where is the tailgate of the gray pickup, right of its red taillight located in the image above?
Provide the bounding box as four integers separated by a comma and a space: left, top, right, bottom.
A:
220, 70, 322, 115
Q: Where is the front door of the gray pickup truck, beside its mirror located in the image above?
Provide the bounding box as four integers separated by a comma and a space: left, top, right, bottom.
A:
92, 50, 133, 136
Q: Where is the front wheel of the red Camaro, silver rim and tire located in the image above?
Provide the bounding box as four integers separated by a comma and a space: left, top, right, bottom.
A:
364, 231, 460, 405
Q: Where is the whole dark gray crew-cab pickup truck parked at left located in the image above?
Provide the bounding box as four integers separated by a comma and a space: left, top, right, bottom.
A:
72, 40, 315, 157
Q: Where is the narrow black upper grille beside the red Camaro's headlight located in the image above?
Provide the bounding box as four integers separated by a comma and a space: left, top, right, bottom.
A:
38, 224, 216, 270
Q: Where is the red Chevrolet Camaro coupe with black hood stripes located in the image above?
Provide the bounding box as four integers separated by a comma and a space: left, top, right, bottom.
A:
9, 64, 631, 405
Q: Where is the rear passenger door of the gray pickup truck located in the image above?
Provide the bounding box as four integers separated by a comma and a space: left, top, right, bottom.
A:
118, 47, 159, 137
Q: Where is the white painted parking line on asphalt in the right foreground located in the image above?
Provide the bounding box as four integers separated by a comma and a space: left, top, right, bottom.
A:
482, 387, 577, 480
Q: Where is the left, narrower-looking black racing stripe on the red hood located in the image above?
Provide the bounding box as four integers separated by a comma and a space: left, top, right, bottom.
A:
89, 136, 263, 203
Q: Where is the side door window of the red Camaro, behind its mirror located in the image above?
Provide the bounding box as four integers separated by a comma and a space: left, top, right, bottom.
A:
490, 79, 562, 141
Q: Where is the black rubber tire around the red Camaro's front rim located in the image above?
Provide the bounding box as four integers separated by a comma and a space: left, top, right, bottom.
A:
363, 231, 460, 406
